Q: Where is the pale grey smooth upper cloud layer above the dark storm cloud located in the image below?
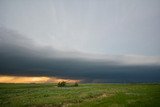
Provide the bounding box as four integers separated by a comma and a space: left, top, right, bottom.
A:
0, 0, 160, 55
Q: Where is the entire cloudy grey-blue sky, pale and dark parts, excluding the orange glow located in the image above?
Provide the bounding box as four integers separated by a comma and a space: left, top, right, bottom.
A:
0, 0, 160, 82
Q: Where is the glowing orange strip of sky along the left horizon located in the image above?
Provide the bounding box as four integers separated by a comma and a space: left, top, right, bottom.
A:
0, 75, 80, 83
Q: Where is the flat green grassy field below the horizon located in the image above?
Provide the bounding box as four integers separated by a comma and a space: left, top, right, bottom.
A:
0, 84, 160, 107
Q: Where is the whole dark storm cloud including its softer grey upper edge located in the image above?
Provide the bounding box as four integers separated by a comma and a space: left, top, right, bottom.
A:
0, 27, 160, 82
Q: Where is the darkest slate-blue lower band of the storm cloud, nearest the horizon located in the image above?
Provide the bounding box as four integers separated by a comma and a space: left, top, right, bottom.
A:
0, 54, 160, 83
